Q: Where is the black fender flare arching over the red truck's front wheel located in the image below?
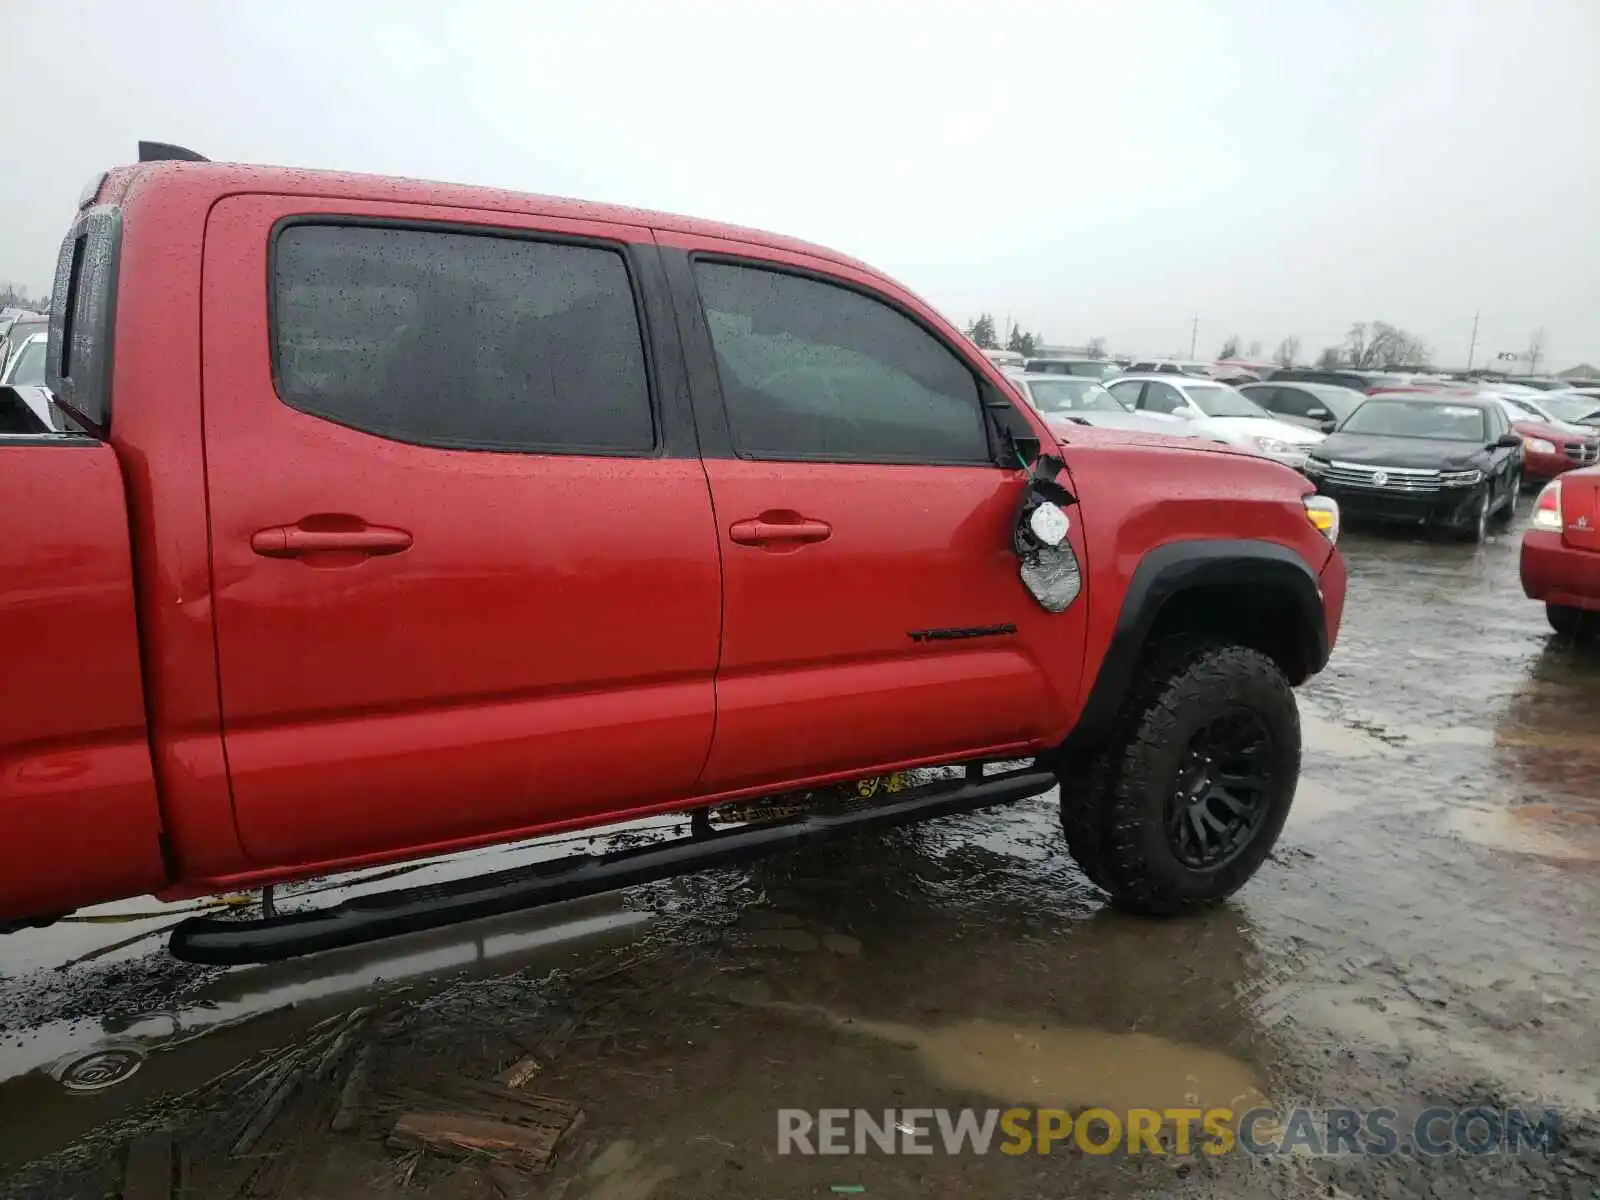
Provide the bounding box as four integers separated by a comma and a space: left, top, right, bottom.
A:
1061, 539, 1330, 755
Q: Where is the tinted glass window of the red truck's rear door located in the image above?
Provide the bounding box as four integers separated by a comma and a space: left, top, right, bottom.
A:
274, 226, 656, 453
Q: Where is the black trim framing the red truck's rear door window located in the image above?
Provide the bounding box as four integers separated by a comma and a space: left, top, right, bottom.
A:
267, 213, 667, 459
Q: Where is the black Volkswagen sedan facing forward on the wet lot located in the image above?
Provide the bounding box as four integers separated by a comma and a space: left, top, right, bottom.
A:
1304, 394, 1522, 542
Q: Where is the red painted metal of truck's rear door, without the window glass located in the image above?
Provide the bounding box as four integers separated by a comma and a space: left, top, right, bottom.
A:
203, 195, 720, 864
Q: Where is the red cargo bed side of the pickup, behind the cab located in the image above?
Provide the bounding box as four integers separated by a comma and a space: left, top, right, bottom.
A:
0, 437, 166, 920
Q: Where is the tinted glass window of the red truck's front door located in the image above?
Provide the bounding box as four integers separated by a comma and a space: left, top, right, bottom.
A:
694, 262, 989, 462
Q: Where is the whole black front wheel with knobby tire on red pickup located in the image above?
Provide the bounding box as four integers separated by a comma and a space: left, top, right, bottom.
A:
1061, 643, 1301, 915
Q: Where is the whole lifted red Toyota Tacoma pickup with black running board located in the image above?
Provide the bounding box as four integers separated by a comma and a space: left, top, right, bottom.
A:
0, 144, 1346, 963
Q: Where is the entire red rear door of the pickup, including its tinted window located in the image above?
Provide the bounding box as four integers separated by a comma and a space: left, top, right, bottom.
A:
203, 195, 722, 864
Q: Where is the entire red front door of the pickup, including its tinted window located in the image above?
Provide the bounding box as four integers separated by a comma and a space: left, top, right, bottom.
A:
658, 230, 1085, 790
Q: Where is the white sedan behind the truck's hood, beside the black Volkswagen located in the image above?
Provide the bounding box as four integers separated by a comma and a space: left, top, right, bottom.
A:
1106, 374, 1325, 470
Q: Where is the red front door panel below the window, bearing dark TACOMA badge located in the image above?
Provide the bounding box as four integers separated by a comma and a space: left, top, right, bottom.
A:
704, 459, 1080, 790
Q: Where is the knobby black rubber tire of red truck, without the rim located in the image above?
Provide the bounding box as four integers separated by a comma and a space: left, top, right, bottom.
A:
1061, 640, 1301, 917
